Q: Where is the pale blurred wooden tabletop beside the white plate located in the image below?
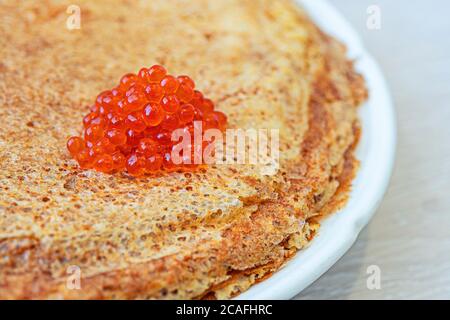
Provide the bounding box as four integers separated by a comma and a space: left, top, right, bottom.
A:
296, 0, 450, 299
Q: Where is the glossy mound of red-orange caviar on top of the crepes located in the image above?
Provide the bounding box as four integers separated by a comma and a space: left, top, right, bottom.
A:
67, 65, 227, 176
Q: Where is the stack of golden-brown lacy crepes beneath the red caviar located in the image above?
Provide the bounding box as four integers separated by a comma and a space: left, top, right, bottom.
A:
0, 0, 367, 299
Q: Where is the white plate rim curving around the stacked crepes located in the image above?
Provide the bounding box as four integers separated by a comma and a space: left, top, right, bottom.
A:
237, 0, 396, 299
